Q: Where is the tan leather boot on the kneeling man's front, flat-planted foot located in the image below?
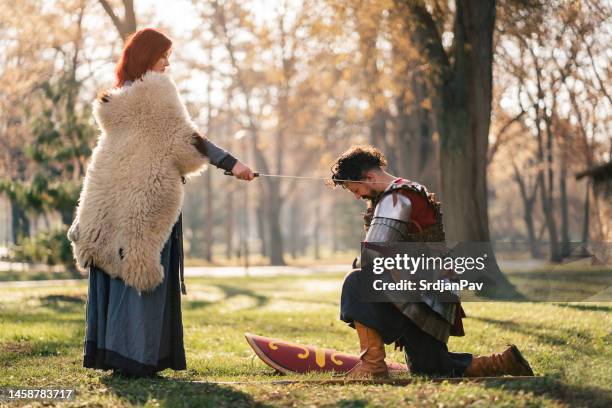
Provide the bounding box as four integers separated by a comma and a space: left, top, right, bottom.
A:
344, 322, 389, 379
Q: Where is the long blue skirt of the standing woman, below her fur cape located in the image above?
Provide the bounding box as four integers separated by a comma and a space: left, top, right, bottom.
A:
83, 217, 186, 375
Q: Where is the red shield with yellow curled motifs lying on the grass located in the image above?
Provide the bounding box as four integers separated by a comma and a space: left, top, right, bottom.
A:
244, 333, 408, 374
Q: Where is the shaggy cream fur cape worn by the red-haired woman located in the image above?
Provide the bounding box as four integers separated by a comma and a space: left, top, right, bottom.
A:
68, 72, 205, 292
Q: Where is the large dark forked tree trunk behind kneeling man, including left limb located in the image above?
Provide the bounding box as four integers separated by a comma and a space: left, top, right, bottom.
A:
396, 0, 518, 297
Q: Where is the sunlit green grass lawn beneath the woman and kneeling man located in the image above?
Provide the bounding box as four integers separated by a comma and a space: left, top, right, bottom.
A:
0, 275, 612, 407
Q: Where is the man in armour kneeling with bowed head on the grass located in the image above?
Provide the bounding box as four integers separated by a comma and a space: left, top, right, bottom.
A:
332, 146, 533, 378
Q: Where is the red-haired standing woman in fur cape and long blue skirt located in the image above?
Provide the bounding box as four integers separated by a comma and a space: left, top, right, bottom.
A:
68, 28, 254, 376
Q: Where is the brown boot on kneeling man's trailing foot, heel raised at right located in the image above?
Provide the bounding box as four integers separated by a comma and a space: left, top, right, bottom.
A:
463, 344, 533, 377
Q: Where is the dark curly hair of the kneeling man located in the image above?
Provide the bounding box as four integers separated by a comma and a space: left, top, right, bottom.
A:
331, 145, 387, 187
